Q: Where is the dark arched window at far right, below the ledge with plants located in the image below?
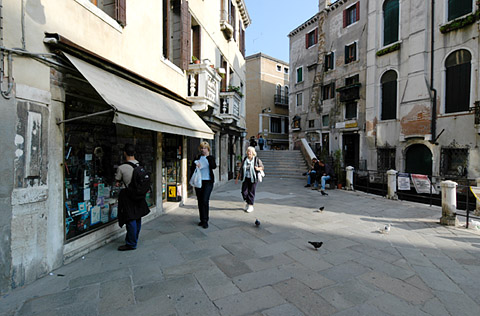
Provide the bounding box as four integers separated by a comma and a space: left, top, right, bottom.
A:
445, 49, 472, 113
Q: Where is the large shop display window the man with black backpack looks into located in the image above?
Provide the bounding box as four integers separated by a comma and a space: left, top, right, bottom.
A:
64, 95, 156, 240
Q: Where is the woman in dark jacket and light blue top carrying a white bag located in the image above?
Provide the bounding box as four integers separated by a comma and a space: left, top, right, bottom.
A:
190, 142, 217, 228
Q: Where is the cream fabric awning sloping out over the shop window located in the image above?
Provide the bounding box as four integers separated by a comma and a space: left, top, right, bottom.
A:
64, 53, 214, 139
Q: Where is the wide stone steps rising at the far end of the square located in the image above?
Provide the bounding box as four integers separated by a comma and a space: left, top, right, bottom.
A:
257, 150, 307, 181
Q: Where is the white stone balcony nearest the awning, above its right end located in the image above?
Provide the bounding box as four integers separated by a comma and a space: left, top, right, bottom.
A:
187, 61, 222, 111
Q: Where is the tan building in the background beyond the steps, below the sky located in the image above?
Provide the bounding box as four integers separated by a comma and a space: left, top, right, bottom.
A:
246, 53, 290, 149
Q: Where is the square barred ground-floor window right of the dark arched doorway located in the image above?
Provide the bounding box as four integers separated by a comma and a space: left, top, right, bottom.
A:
440, 148, 468, 177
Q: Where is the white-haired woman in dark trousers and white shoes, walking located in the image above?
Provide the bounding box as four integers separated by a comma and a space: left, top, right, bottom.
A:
235, 146, 263, 213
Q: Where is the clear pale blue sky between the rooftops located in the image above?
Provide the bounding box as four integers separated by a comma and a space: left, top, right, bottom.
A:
245, 0, 318, 63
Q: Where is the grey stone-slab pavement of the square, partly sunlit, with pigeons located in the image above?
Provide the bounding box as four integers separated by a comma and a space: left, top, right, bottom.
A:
0, 176, 480, 316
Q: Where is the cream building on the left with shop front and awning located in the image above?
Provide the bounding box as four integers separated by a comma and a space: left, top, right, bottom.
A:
0, 0, 250, 293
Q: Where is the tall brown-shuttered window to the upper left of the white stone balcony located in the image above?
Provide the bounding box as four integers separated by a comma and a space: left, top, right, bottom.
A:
163, 0, 190, 70
